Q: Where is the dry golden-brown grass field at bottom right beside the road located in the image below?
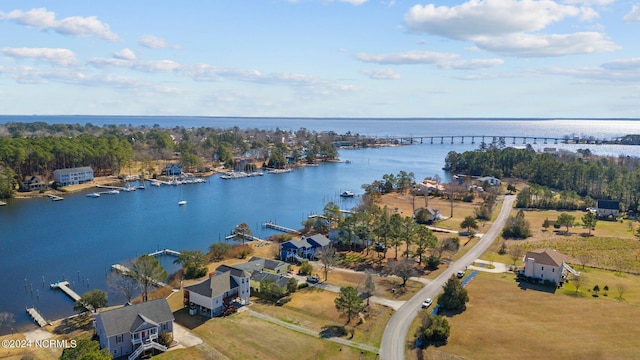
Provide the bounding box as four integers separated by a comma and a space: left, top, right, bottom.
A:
407, 270, 640, 360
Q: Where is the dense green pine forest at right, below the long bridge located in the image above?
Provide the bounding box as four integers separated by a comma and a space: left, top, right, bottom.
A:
444, 146, 640, 211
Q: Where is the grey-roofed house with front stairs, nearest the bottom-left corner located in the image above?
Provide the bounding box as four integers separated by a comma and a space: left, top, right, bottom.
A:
94, 299, 174, 360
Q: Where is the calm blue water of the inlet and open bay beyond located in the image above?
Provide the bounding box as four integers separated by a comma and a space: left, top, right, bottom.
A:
0, 116, 640, 331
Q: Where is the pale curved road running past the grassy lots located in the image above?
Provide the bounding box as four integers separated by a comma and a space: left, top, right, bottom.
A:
380, 195, 516, 360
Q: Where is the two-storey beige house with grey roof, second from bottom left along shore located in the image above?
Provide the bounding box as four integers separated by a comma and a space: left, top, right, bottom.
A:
184, 265, 251, 318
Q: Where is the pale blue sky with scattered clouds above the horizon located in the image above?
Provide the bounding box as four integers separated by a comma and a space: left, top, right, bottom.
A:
0, 0, 640, 118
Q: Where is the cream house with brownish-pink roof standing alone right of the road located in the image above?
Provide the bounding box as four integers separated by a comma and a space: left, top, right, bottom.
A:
522, 249, 579, 286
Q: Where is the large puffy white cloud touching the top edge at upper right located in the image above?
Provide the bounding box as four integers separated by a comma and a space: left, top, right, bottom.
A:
405, 0, 581, 40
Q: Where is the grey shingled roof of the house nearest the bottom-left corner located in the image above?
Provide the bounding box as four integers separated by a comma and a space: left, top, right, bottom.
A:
95, 299, 174, 337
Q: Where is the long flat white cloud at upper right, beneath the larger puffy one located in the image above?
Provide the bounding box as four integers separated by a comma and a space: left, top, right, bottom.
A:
476, 32, 620, 57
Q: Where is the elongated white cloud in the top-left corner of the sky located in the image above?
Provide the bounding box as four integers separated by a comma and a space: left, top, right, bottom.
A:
0, 8, 119, 41
